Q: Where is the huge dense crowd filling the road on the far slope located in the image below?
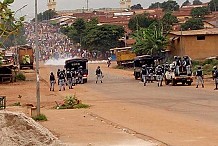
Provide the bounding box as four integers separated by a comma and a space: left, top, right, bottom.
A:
25, 22, 109, 61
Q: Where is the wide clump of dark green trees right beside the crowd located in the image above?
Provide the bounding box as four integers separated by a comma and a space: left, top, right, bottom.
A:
61, 18, 124, 52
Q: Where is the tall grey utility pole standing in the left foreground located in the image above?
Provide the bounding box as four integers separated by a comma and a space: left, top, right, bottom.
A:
35, 0, 40, 116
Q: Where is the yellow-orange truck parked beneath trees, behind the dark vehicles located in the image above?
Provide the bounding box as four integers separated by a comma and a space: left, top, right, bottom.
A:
110, 47, 136, 65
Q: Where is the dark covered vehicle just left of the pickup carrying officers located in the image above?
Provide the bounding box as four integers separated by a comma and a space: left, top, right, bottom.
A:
134, 55, 155, 80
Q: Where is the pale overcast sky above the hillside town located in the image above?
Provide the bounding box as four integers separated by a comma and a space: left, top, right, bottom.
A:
0, 0, 209, 18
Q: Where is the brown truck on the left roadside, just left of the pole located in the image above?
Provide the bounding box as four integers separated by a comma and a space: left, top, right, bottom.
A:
18, 45, 34, 69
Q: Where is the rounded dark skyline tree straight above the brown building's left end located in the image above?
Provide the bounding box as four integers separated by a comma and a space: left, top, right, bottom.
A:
161, 0, 179, 11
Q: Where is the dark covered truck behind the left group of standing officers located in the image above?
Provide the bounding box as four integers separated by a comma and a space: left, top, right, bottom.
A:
64, 58, 88, 83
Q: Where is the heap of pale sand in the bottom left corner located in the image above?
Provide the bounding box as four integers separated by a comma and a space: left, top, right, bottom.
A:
0, 111, 61, 146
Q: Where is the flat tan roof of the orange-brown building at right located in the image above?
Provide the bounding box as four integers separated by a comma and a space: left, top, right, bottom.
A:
170, 28, 218, 36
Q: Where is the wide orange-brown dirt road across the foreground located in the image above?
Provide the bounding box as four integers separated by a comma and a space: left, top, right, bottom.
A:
0, 61, 218, 146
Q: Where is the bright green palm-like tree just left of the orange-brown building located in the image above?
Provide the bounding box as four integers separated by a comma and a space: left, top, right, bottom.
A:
133, 23, 168, 56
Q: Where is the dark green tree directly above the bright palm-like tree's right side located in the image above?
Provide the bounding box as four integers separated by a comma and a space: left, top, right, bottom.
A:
162, 12, 178, 32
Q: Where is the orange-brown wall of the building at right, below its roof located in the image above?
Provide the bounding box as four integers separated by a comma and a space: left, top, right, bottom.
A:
169, 35, 218, 59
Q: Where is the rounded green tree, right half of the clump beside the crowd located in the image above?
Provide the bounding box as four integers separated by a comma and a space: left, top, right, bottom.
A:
82, 25, 124, 52
